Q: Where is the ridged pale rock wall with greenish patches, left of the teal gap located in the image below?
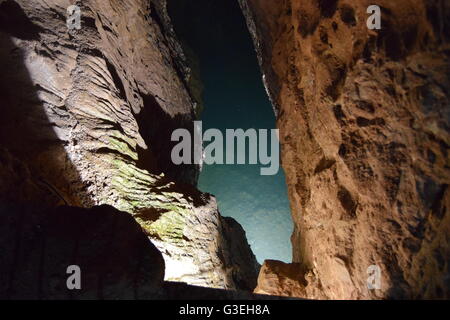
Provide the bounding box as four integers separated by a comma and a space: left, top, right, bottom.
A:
0, 0, 257, 290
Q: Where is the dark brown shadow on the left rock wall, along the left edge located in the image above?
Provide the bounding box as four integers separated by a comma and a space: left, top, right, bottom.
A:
0, 1, 89, 205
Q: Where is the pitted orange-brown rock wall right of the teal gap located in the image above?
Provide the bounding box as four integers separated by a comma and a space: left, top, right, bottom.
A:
240, 0, 450, 299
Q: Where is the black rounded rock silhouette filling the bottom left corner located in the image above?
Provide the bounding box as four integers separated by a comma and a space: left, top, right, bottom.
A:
0, 204, 164, 300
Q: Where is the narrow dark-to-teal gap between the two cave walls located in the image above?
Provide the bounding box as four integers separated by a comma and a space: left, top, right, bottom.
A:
169, 0, 293, 263
